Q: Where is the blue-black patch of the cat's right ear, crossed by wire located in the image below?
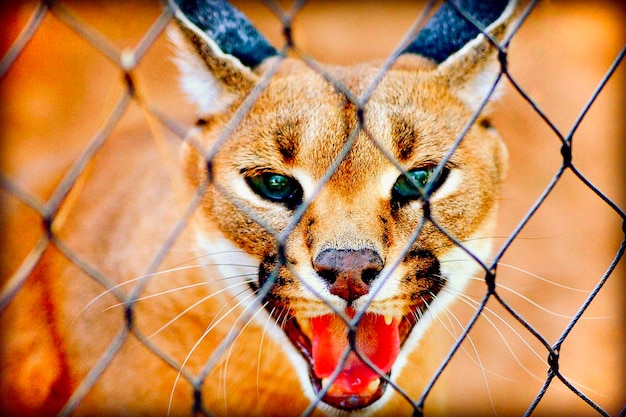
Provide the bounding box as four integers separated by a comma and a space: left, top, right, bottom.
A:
404, 0, 509, 63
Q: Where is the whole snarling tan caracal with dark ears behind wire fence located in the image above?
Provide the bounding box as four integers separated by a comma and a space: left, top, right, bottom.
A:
1, 0, 516, 415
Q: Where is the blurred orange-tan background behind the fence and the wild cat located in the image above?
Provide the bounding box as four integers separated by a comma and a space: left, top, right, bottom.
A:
0, 0, 626, 416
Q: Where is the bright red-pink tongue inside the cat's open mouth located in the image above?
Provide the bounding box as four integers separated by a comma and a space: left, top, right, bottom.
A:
311, 310, 400, 395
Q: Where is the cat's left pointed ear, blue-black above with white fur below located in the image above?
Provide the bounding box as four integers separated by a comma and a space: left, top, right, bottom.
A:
169, 0, 277, 117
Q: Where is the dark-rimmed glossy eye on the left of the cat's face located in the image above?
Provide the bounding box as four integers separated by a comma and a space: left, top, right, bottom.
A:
245, 172, 303, 209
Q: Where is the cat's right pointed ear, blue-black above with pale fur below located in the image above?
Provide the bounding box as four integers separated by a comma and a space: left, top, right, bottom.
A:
405, 0, 517, 110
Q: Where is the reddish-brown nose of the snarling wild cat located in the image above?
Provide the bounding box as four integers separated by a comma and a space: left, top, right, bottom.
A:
313, 249, 384, 305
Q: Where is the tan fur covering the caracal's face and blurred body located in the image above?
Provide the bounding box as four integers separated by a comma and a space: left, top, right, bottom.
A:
0, 3, 507, 416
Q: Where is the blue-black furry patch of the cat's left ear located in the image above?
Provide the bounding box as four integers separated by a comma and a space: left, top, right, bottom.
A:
174, 0, 278, 68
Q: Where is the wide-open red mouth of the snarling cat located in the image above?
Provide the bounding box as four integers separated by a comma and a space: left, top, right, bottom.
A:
281, 300, 429, 410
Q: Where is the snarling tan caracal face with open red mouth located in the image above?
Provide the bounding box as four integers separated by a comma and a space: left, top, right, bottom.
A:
174, 0, 512, 411
